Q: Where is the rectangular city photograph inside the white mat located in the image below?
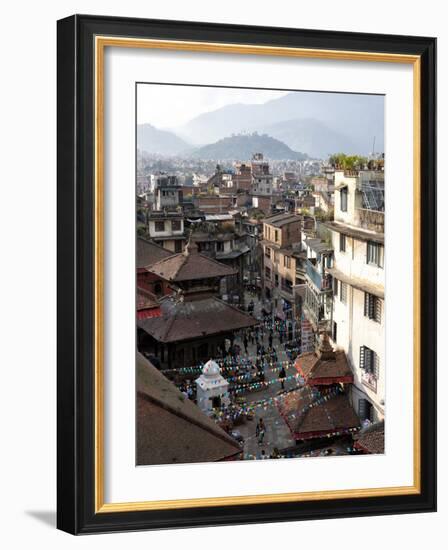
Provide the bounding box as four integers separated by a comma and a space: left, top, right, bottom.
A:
135, 82, 384, 466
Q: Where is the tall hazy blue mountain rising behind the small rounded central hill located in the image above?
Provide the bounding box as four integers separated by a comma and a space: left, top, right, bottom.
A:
173, 92, 384, 158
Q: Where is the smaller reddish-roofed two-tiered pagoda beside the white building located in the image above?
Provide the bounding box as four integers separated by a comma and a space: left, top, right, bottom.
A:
277, 332, 360, 442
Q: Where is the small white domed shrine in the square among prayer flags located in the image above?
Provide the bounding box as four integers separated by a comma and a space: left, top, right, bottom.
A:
196, 359, 230, 413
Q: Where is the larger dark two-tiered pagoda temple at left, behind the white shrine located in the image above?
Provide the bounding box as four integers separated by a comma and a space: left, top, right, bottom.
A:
137, 242, 256, 369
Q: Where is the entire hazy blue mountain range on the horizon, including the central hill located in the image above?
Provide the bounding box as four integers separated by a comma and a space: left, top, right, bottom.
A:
137, 92, 384, 159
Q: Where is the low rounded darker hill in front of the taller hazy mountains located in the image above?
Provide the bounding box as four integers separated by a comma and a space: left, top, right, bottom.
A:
190, 133, 308, 160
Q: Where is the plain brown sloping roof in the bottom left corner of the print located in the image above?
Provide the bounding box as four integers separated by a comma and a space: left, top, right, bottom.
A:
137, 353, 241, 465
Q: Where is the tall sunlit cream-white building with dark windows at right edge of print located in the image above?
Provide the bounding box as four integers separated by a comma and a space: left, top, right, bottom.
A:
326, 170, 385, 422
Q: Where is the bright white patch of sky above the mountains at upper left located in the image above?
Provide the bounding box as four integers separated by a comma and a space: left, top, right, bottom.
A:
137, 84, 289, 128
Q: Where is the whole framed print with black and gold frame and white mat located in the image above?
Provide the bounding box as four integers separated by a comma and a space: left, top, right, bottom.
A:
58, 15, 436, 534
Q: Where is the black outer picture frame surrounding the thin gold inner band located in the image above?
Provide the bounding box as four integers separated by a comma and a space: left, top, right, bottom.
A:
57, 15, 436, 534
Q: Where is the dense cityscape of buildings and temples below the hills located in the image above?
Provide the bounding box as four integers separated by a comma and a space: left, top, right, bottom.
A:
136, 143, 385, 464
